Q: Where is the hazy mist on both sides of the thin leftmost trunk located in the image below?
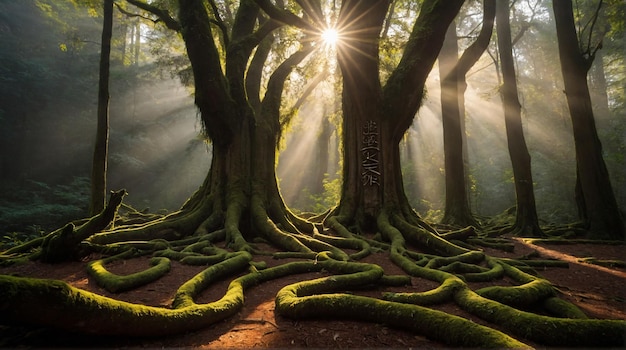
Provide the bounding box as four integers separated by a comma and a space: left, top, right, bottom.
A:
0, 2, 211, 232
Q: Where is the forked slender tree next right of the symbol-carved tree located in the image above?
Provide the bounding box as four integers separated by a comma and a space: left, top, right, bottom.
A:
439, 0, 496, 226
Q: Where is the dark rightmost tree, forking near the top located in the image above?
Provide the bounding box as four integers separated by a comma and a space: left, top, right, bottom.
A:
552, 0, 626, 239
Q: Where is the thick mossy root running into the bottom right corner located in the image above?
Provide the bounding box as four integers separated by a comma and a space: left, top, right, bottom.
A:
455, 288, 626, 347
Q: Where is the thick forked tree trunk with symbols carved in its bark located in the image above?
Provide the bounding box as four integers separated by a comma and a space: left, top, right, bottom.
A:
327, 0, 463, 254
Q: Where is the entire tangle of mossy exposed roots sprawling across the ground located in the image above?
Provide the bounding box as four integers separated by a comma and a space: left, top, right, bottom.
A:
0, 189, 626, 348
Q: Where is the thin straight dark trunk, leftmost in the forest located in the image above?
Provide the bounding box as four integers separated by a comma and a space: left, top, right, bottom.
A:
89, 0, 113, 215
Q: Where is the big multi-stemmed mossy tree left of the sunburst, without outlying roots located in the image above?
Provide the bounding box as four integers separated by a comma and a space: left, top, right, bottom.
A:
86, 0, 338, 253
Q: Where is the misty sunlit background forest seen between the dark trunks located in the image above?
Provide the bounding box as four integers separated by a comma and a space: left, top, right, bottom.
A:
0, 0, 626, 241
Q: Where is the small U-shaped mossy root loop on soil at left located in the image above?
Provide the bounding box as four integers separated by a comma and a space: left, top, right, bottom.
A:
87, 250, 170, 293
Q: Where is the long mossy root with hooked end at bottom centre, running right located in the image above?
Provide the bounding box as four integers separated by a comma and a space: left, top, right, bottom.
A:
276, 276, 529, 348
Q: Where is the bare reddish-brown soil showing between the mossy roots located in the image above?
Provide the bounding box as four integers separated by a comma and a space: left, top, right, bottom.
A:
0, 237, 626, 349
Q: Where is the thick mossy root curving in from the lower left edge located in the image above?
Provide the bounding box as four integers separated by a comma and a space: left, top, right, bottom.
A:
0, 253, 251, 336
